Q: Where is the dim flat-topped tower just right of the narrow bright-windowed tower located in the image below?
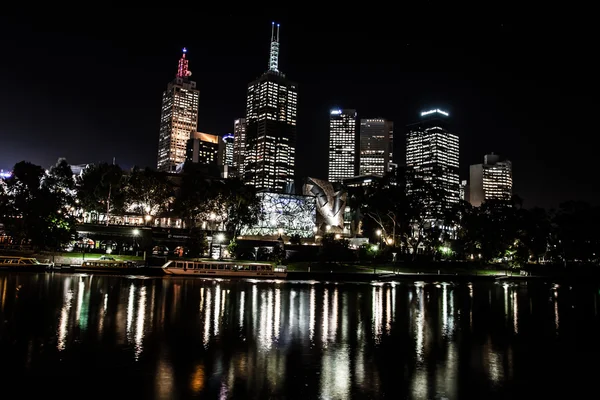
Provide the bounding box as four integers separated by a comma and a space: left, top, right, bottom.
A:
358, 118, 394, 176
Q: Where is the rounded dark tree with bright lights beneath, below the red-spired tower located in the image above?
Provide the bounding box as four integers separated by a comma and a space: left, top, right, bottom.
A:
124, 167, 173, 215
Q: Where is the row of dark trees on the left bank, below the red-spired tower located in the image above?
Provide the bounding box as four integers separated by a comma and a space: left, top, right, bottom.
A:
0, 159, 260, 253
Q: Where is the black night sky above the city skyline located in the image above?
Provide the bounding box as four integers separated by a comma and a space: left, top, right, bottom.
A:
0, 10, 600, 207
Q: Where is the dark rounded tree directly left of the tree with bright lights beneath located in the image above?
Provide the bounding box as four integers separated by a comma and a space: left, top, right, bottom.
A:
76, 163, 125, 225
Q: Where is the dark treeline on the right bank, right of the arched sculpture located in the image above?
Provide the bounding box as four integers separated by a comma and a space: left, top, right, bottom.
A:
349, 171, 600, 266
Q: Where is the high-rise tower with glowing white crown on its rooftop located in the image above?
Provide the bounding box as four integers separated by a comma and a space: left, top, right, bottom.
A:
406, 109, 460, 210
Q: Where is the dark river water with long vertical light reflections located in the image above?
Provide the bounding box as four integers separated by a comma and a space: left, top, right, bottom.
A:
0, 273, 600, 400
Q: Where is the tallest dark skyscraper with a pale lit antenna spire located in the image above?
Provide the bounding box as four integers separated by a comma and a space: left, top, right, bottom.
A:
243, 23, 298, 192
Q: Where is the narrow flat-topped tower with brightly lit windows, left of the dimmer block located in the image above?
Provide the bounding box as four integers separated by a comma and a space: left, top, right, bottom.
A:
327, 109, 357, 182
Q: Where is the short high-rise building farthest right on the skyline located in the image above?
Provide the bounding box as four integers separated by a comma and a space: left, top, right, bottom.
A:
469, 153, 512, 207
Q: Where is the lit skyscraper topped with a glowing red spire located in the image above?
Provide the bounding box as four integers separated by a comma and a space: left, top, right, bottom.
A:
156, 48, 200, 172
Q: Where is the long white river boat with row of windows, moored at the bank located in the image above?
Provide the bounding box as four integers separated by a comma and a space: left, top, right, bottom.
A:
162, 261, 287, 279
